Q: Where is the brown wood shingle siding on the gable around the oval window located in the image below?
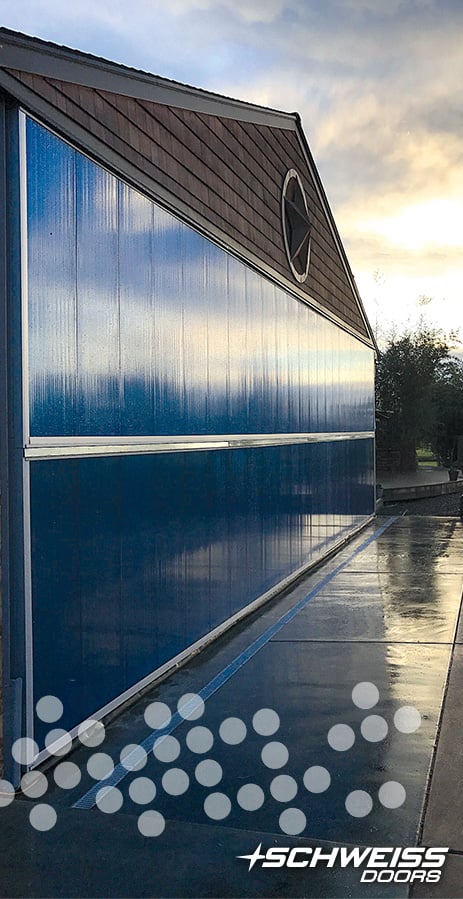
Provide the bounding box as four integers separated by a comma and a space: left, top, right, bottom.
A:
10, 70, 368, 336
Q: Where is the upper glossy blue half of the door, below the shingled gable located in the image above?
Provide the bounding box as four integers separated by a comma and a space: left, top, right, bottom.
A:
27, 119, 374, 436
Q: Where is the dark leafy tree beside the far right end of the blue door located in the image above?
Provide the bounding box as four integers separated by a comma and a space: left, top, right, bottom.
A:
376, 319, 455, 471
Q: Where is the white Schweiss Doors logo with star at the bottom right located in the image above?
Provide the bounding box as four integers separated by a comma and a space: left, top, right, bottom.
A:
237, 843, 449, 883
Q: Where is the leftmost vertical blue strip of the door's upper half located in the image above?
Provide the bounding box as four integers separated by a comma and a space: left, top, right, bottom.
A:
27, 120, 77, 436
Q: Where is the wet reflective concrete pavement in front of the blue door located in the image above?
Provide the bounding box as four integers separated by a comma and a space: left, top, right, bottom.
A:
0, 516, 463, 897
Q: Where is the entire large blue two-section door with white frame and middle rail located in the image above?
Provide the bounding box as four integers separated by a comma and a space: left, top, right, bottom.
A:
0, 113, 374, 765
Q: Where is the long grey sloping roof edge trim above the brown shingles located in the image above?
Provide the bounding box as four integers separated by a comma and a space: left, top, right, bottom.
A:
0, 28, 297, 131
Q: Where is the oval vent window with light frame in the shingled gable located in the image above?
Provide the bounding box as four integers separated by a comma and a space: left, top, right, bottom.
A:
281, 169, 311, 282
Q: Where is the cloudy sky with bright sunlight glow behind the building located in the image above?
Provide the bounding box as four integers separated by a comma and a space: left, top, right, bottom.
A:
0, 0, 463, 350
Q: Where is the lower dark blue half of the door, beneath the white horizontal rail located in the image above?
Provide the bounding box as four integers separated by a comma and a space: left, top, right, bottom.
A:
31, 439, 373, 740
